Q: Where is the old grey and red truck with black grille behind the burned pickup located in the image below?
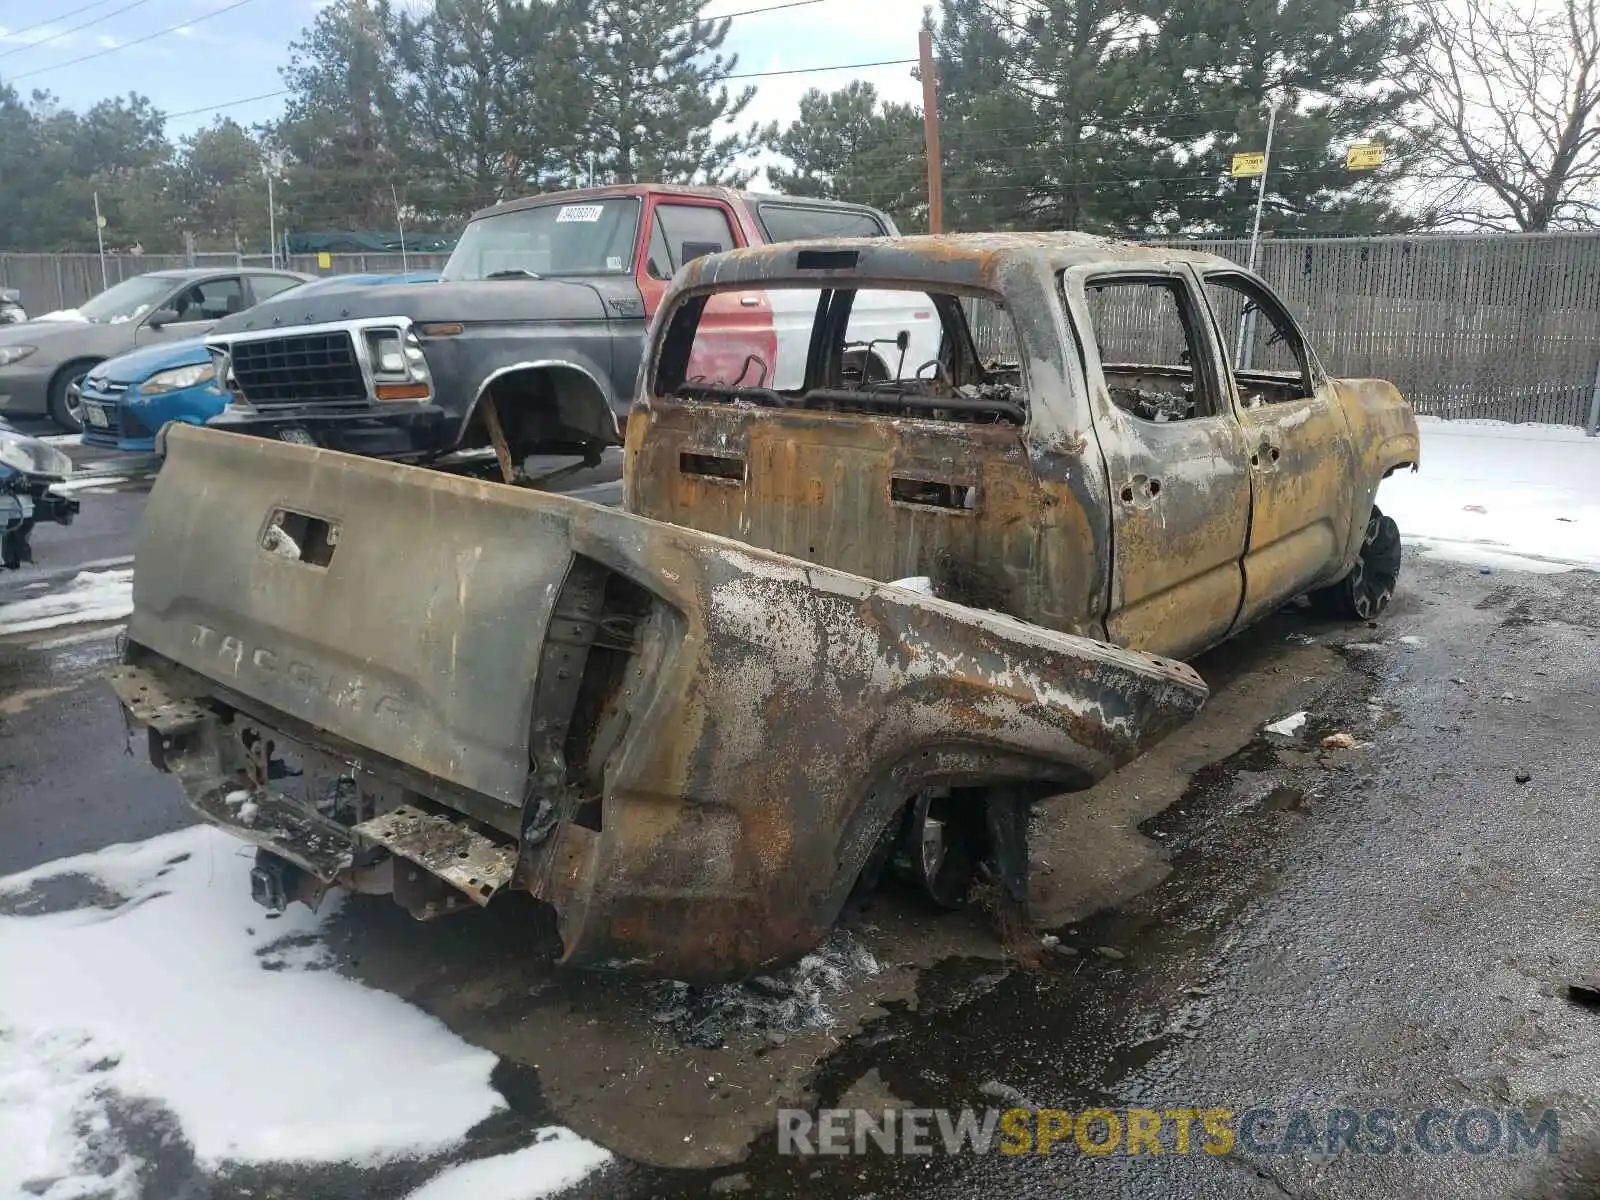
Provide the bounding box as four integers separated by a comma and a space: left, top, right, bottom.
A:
208, 184, 939, 477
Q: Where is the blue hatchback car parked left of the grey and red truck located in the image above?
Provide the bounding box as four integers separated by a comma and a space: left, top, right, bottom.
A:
78, 272, 438, 453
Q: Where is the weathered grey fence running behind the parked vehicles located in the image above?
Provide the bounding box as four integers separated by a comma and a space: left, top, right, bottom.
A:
12, 234, 1600, 429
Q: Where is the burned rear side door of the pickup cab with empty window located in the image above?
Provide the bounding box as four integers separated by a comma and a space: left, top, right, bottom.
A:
1059, 259, 1251, 658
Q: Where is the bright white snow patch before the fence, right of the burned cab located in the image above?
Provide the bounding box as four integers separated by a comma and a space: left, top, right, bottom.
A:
1378, 418, 1600, 571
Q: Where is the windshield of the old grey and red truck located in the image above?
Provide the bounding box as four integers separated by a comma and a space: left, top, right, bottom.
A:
440, 197, 638, 282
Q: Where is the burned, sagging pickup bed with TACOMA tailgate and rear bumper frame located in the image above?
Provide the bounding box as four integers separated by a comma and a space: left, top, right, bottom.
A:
115, 427, 1206, 979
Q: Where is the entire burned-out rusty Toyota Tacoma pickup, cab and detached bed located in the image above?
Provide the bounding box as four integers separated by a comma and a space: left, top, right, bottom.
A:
115, 235, 1418, 979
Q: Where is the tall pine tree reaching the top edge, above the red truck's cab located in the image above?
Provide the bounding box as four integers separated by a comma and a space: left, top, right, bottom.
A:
581, 0, 760, 184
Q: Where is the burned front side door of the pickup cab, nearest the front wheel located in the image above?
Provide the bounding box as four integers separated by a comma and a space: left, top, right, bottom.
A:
1189, 266, 1366, 626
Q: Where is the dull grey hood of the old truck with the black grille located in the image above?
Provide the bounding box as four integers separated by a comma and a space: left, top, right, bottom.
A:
211, 278, 606, 329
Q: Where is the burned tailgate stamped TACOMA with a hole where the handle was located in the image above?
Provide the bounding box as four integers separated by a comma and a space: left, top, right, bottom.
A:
128, 426, 576, 806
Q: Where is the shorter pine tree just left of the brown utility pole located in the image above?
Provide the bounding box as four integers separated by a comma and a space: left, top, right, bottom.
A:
766, 80, 928, 232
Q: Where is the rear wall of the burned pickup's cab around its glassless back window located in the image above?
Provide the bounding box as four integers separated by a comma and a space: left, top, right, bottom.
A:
624, 262, 1110, 637
